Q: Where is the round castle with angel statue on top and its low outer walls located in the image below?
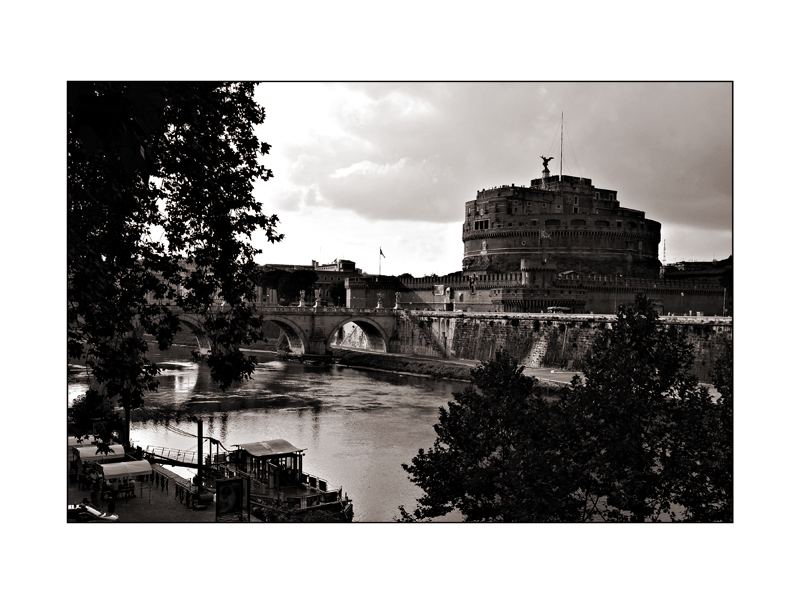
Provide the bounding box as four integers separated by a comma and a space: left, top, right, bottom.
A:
346, 157, 730, 315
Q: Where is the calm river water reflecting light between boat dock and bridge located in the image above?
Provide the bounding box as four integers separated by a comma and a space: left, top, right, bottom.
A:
73, 347, 465, 522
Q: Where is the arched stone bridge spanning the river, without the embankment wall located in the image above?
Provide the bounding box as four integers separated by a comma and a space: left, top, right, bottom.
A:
178, 305, 402, 356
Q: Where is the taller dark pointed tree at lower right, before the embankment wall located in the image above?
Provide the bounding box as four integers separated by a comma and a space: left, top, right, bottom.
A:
564, 295, 719, 522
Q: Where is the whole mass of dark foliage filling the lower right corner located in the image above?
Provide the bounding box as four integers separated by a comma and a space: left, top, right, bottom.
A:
400, 296, 733, 521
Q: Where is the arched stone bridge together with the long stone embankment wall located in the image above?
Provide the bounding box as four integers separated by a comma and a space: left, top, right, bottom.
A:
161, 305, 733, 381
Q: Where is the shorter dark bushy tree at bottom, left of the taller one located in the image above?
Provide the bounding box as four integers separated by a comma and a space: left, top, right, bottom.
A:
400, 351, 581, 521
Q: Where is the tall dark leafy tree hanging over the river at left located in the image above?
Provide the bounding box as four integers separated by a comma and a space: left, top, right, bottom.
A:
67, 82, 281, 442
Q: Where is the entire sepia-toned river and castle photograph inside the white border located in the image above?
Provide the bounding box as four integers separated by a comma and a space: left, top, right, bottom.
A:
65, 80, 732, 531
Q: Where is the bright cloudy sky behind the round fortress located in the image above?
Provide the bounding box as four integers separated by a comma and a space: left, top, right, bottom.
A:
256, 83, 732, 276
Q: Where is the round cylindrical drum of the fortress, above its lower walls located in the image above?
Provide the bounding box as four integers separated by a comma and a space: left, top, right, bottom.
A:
462, 176, 661, 278
